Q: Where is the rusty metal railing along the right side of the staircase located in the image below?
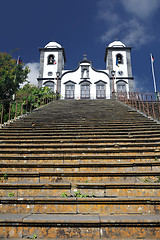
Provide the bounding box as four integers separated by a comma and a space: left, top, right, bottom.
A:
116, 92, 160, 120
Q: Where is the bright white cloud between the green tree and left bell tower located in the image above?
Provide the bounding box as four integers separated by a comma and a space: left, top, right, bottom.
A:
23, 62, 39, 86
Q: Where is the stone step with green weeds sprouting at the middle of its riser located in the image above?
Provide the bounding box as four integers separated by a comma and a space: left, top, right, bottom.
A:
0, 183, 160, 198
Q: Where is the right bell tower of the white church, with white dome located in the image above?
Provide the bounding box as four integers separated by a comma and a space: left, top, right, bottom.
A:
105, 41, 134, 97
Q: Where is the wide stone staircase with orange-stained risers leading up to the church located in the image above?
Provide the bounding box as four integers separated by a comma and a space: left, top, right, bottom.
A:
0, 100, 160, 240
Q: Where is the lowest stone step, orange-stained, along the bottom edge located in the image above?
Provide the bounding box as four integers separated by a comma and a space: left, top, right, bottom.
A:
0, 214, 160, 239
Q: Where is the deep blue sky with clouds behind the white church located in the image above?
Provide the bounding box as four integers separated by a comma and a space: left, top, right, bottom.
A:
0, 0, 160, 92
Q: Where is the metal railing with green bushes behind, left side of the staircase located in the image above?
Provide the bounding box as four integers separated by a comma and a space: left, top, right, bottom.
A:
0, 95, 55, 127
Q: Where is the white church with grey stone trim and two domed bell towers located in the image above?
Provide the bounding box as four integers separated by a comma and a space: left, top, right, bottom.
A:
37, 41, 134, 99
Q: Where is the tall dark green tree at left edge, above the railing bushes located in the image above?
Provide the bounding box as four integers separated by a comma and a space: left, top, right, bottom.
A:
0, 52, 29, 99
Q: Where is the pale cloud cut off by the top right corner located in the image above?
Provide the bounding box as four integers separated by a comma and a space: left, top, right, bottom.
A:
121, 0, 160, 19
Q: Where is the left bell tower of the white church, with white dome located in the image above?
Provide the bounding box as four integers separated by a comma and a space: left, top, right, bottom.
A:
37, 42, 66, 92
